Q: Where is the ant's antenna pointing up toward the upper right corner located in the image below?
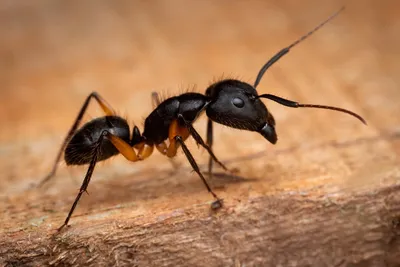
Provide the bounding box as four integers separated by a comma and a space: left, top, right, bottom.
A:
254, 7, 344, 88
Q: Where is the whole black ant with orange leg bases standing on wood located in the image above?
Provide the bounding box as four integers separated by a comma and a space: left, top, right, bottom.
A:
40, 8, 366, 230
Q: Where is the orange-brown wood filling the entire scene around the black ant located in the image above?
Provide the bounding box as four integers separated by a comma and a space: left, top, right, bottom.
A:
0, 0, 400, 266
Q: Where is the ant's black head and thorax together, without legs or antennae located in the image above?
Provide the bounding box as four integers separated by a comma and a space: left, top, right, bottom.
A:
143, 84, 277, 147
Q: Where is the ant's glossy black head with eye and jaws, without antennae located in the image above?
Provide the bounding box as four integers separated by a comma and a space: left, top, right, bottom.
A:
206, 80, 277, 144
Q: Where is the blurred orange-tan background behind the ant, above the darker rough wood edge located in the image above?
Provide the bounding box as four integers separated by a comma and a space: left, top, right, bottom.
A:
0, 0, 400, 226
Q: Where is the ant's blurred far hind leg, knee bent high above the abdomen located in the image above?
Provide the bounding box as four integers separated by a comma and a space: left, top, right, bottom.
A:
38, 92, 115, 187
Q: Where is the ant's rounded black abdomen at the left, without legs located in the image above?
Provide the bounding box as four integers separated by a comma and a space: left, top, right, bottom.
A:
64, 116, 130, 165
